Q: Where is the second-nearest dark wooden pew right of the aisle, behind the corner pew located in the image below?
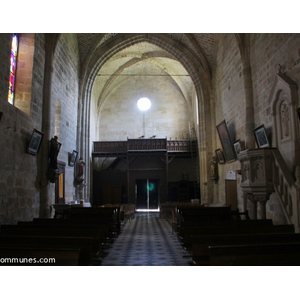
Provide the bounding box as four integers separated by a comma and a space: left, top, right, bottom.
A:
192, 233, 300, 265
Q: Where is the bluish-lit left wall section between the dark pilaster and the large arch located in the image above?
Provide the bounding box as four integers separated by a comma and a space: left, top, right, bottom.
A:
51, 34, 81, 203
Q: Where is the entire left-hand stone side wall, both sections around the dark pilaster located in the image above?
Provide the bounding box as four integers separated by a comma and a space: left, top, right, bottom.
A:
0, 34, 79, 224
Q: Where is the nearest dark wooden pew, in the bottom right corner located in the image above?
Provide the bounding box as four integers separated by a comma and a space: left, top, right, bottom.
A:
209, 242, 300, 266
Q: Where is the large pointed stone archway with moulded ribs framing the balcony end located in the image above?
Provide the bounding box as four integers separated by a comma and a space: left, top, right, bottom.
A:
78, 34, 215, 203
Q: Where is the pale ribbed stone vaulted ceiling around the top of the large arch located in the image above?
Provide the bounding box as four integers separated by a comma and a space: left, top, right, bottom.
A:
77, 33, 217, 107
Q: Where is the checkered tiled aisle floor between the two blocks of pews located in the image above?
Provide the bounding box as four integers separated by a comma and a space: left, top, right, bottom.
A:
101, 212, 190, 266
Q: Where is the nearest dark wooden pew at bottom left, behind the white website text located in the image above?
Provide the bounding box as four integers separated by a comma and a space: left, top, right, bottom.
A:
0, 246, 80, 266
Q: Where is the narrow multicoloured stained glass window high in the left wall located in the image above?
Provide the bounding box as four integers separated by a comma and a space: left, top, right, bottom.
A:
8, 33, 19, 104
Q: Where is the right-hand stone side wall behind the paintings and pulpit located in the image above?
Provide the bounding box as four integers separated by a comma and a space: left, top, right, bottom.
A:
214, 34, 300, 219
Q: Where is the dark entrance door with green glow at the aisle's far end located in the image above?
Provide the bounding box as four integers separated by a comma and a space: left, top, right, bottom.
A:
136, 179, 159, 209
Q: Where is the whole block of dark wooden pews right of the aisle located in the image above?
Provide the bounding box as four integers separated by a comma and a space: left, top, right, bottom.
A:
172, 204, 300, 266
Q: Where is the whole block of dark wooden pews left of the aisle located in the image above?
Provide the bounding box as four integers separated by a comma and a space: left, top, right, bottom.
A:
0, 206, 121, 266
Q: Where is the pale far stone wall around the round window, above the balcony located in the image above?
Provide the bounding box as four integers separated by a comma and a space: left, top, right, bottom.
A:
94, 64, 189, 141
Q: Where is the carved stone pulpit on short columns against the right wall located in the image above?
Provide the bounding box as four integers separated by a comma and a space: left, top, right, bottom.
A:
238, 148, 274, 219
